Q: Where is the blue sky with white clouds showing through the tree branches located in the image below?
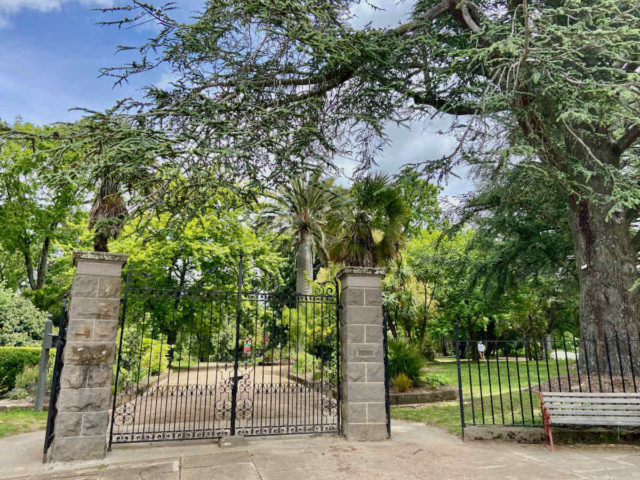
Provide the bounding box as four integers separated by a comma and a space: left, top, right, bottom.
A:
0, 0, 473, 198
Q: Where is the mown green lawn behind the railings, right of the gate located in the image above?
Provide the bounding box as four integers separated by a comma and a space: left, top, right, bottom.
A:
391, 357, 575, 435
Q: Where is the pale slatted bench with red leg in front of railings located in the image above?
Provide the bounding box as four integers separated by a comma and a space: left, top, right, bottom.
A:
538, 392, 640, 451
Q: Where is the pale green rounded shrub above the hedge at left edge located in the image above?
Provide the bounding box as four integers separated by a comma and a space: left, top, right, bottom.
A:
0, 284, 46, 347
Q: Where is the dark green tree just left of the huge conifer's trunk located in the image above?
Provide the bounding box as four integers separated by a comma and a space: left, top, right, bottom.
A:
463, 166, 579, 336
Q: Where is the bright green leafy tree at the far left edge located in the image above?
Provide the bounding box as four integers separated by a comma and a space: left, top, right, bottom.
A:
0, 123, 83, 291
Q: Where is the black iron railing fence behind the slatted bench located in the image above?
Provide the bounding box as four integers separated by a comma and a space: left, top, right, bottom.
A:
455, 331, 640, 429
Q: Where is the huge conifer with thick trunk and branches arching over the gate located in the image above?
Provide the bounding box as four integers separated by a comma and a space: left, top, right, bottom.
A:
12, 0, 640, 338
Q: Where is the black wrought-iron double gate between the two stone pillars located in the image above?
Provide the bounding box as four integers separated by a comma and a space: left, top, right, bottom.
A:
109, 260, 340, 445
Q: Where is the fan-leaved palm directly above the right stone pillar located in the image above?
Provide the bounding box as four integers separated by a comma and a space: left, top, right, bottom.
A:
329, 174, 409, 267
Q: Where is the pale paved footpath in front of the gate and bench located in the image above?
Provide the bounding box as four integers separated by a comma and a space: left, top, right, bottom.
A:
0, 421, 640, 480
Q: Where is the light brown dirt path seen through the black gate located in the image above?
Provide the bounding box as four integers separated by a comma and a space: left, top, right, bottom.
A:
114, 363, 337, 443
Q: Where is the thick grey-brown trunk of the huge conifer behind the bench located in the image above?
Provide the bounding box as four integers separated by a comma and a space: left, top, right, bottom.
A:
569, 146, 640, 374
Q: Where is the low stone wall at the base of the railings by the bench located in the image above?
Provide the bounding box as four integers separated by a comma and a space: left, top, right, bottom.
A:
464, 425, 640, 444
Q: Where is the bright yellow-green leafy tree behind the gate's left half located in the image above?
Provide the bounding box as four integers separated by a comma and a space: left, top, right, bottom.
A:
111, 192, 283, 361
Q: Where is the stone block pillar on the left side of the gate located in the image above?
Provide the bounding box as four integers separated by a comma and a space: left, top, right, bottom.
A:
50, 252, 128, 462
